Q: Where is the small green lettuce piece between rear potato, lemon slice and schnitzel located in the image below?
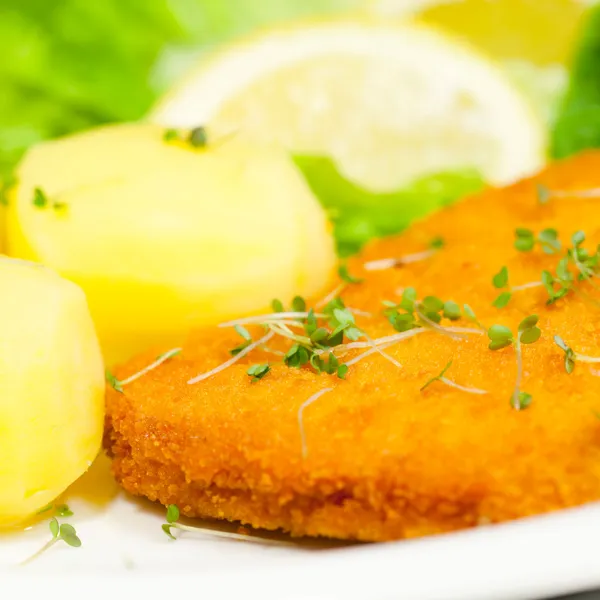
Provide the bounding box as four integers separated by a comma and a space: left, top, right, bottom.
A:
294, 156, 485, 256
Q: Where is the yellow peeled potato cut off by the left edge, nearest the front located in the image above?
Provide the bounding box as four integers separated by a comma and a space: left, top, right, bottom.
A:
0, 256, 104, 526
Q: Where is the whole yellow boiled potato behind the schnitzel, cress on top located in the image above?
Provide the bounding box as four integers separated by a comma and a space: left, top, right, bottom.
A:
7, 124, 335, 364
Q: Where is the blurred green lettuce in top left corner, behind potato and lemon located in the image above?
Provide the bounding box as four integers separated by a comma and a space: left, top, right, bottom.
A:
0, 0, 360, 178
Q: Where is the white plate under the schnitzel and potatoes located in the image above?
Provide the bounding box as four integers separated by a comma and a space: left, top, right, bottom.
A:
0, 454, 600, 600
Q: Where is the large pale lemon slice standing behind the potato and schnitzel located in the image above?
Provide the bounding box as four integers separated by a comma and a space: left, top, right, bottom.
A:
150, 21, 546, 192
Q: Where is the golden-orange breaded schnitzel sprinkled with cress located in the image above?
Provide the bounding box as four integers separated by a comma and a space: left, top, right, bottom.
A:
105, 152, 600, 541
